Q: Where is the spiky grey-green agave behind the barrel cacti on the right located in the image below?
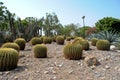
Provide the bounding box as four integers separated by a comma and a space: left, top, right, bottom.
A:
88, 31, 120, 44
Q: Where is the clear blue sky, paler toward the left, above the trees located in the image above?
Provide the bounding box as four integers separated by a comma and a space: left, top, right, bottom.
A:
1, 0, 120, 26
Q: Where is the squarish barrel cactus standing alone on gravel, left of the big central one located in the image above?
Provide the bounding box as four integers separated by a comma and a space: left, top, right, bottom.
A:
33, 44, 47, 58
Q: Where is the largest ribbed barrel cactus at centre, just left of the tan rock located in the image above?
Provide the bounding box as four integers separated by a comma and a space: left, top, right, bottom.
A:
63, 43, 83, 60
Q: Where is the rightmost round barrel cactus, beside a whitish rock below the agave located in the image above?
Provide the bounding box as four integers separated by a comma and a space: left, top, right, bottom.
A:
96, 40, 110, 50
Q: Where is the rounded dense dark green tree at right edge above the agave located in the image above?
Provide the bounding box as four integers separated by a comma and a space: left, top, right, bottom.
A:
95, 17, 120, 32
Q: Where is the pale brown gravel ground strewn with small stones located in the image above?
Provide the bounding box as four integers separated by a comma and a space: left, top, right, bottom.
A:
0, 43, 120, 80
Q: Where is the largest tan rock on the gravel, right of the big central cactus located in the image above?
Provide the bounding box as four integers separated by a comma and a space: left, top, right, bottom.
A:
85, 55, 99, 67
